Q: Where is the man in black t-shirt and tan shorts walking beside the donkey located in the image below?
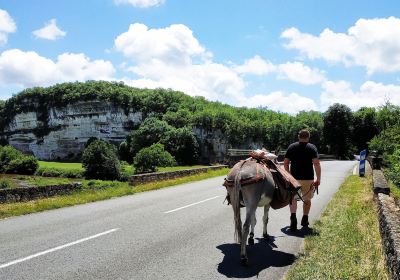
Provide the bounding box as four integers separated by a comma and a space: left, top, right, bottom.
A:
283, 129, 321, 231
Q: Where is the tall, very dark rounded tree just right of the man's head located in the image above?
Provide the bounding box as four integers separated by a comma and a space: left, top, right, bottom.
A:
324, 103, 353, 159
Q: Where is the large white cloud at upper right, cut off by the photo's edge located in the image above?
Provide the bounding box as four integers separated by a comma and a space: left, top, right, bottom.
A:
281, 17, 400, 74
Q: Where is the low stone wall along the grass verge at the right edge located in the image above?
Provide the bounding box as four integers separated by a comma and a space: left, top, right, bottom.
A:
373, 170, 400, 280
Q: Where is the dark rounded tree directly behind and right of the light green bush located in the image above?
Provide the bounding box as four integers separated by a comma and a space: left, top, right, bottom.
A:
161, 127, 199, 165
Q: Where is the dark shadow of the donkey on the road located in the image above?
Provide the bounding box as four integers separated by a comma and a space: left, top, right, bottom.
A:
217, 236, 296, 278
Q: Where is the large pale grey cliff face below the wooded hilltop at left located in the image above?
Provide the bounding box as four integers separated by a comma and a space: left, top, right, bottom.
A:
4, 101, 142, 160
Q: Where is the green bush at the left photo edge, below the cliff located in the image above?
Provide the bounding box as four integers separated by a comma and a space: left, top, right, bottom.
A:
0, 146, 39, 175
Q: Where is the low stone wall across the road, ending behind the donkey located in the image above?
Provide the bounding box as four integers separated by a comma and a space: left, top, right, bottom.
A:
129, 165, 228, 186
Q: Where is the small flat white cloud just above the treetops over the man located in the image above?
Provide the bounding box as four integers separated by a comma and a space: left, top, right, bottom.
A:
246, 91, 317, 114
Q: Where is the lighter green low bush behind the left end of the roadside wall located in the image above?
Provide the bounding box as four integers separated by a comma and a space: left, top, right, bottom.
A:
133, 143, 176, 173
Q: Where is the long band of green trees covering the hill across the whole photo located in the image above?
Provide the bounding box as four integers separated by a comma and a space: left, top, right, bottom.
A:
0, 81, 400, 184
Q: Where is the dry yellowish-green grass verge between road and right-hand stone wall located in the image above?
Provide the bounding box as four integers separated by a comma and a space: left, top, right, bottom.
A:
286, 175, 389, 279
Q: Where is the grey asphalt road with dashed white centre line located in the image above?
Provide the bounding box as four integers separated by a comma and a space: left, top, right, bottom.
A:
0, 161, 356, 280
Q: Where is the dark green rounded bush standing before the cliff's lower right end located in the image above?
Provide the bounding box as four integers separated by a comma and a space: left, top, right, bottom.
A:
82, 140, 121, 180
